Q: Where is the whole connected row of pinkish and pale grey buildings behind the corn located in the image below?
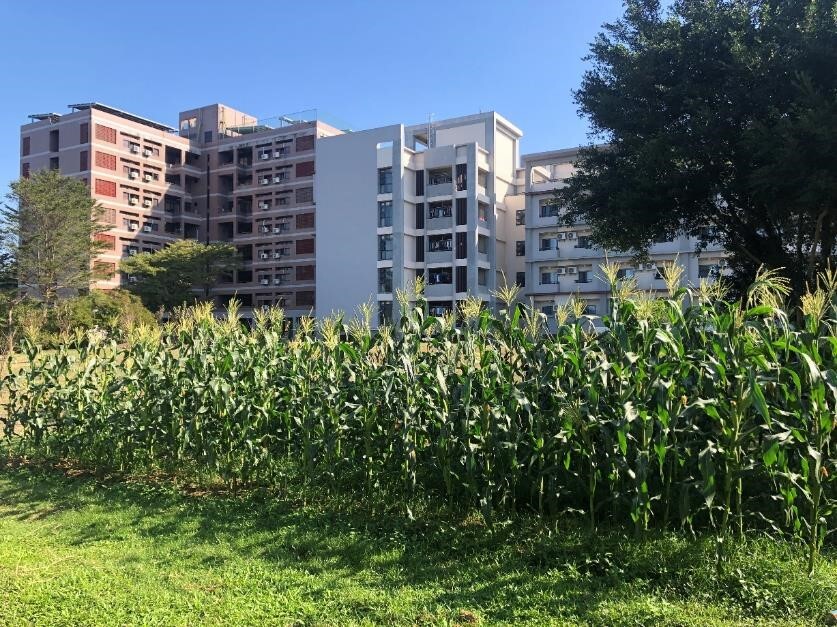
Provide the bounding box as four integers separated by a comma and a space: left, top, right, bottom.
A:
21, 103, 725, 326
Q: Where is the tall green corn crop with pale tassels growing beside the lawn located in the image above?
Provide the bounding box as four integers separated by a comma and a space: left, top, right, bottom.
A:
0, 267, 837, 569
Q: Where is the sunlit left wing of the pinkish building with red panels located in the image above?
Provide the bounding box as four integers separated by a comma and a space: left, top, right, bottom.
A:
20, 103, 203, 289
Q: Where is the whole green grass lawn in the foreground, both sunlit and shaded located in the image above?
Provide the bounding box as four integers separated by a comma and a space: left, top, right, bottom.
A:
0, 467, 837, 626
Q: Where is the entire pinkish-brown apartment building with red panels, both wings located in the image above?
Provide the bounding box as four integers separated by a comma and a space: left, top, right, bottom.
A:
21, 103, 341, 319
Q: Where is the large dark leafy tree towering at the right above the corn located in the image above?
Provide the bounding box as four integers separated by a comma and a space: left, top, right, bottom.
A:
556, 0, 837, 295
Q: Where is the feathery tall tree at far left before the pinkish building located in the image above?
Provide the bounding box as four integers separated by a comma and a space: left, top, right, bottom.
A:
0, 170, 109, 306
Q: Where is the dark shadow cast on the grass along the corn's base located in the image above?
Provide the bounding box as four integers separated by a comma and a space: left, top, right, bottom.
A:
0, 468, 823, 622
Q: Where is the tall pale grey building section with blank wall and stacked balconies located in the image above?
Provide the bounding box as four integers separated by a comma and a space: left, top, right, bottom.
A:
315, 112, 524, 324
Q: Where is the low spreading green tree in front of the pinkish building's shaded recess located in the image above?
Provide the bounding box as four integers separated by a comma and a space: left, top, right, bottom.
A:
119, 240, 239, 311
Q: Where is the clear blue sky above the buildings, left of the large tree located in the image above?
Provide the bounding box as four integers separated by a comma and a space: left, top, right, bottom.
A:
0, 0, 622, 186
